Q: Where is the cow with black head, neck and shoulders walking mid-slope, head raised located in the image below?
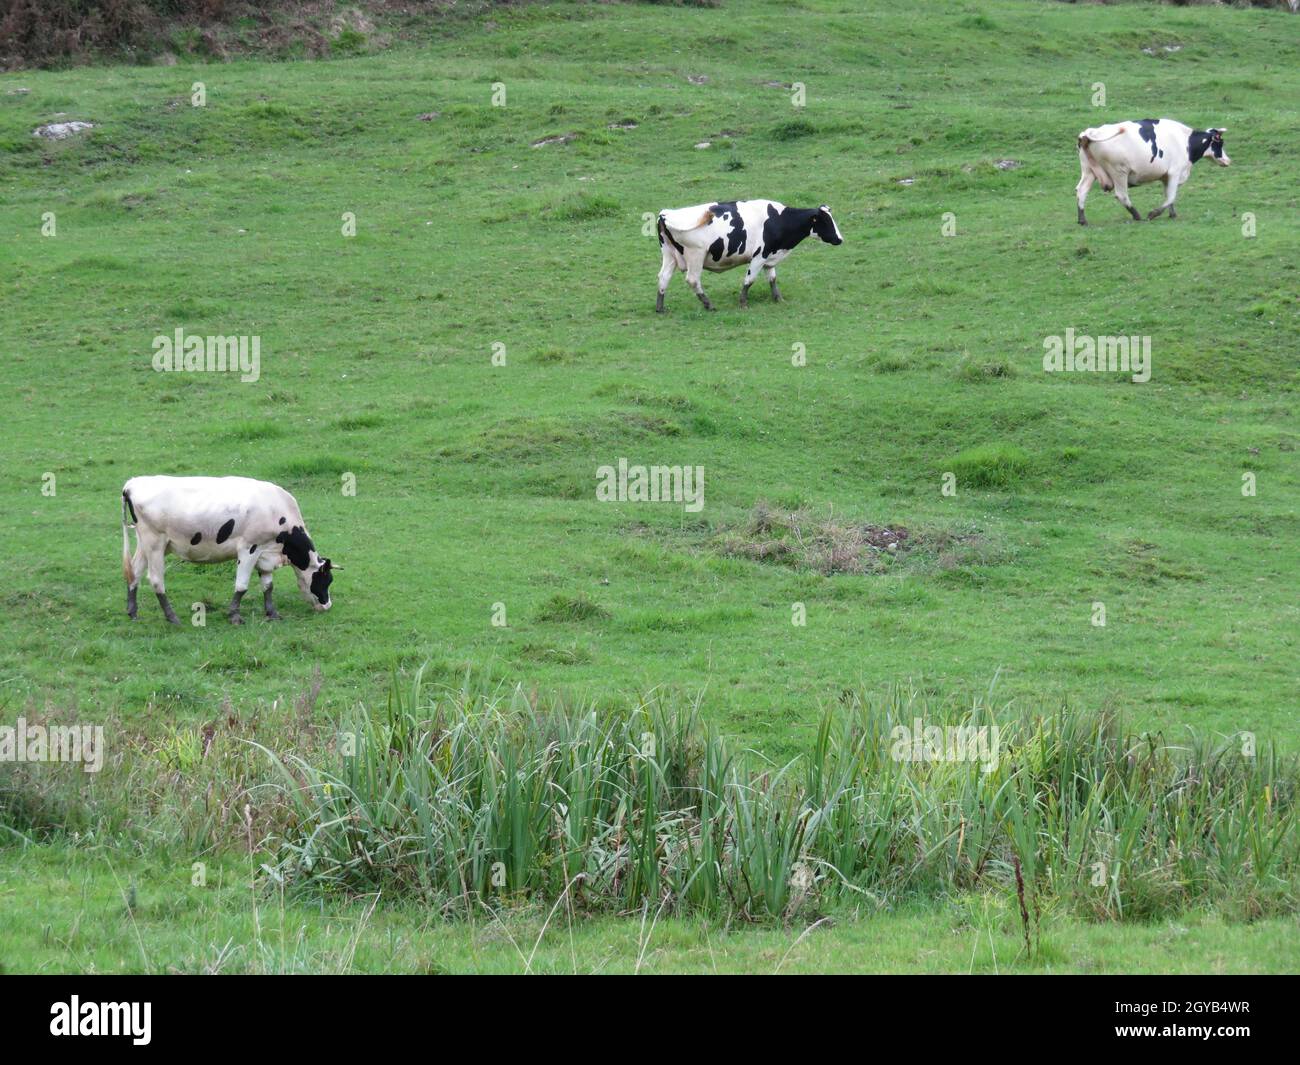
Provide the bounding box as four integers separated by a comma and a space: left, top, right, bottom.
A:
655, 200, 844, 312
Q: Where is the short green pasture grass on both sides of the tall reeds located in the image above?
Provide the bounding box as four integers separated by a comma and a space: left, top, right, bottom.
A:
0, 0, 1300, 971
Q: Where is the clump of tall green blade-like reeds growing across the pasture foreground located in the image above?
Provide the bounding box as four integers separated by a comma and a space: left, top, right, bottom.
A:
268, 674, 1300, 925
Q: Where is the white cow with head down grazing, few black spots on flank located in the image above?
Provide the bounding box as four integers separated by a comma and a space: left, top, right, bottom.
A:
122, 477, 334, 624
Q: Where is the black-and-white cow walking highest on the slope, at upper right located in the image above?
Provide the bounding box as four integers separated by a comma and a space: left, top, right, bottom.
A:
1075, 118, 1232, 225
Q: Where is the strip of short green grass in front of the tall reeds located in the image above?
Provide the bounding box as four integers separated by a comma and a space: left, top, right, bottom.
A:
10, 848, 1300, 974
